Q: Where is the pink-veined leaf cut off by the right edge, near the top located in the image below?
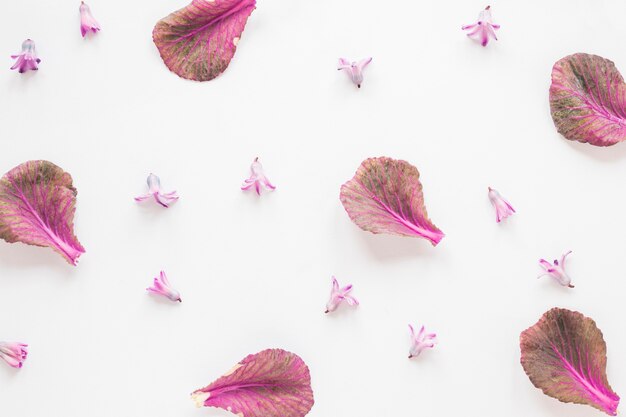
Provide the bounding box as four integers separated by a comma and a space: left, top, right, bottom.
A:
550, 54, 626, 146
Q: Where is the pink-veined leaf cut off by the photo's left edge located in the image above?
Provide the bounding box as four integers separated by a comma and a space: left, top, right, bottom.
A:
0, 161, 85, 265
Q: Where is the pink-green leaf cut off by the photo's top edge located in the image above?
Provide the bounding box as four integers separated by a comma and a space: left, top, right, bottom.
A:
152, 0, 256, 81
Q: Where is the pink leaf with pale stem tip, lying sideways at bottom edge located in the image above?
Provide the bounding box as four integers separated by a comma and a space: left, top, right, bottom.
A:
192, 349, 313, 417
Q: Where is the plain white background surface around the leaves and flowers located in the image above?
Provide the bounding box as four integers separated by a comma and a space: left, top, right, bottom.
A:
0, 0, 626, 417
